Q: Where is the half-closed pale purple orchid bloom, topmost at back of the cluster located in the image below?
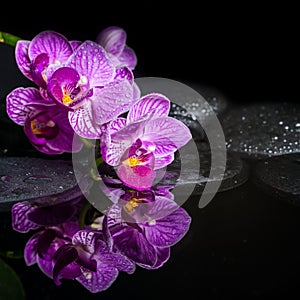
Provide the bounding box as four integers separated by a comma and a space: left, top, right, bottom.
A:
96, 26, 137, 70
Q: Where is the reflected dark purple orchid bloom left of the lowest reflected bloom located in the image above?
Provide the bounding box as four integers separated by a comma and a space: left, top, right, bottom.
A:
24, 222, 79, 279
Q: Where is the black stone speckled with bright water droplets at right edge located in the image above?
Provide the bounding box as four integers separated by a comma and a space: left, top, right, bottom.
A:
221, 102, 300, 158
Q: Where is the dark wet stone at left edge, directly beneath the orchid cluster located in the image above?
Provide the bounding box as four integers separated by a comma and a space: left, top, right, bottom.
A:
0, 156, 77, 210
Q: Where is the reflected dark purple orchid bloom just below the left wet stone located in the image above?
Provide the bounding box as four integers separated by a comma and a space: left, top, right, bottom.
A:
11, 185, 85, 233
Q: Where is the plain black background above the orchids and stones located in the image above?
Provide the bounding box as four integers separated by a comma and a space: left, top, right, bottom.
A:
0, 1, 299, 103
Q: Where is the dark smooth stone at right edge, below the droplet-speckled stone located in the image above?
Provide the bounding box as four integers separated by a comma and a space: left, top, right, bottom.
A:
253, 154, 300, 206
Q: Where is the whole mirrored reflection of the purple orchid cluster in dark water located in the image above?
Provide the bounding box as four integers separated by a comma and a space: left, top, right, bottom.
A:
12, 169, 191, 293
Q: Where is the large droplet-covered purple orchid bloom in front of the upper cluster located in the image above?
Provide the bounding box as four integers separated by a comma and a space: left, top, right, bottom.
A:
47, 41, 140, 139
